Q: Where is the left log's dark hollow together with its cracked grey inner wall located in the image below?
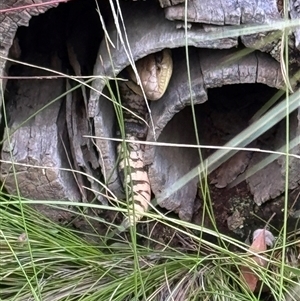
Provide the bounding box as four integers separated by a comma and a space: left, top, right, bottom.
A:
1, 0, 103, 220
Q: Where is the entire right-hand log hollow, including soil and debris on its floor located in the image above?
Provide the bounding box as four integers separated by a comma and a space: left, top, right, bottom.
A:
149, 84, 297, 237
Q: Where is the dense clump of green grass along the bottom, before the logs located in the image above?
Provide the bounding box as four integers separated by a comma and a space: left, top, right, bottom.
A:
0, 193, 300, 301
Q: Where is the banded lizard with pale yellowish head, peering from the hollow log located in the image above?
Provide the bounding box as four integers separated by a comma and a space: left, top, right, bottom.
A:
117, 49, 173, 229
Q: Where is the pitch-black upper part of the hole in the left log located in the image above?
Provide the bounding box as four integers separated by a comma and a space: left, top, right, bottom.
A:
16, 0, 107, 75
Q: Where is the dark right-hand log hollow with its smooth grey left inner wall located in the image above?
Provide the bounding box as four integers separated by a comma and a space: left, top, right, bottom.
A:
149, 84, 277, 219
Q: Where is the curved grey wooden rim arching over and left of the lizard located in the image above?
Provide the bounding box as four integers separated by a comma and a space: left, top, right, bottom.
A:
89, 1, 237, 204
